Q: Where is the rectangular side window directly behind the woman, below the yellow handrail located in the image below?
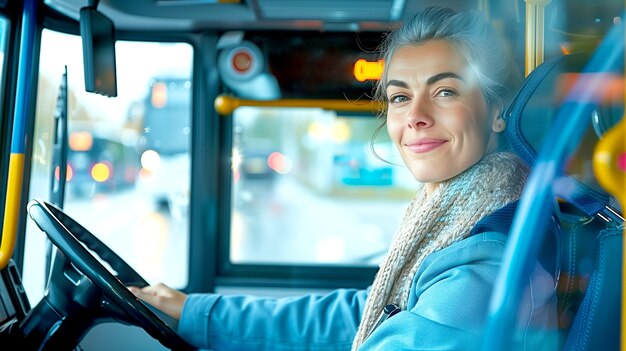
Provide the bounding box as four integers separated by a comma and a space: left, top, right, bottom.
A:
230, 107, 415, 266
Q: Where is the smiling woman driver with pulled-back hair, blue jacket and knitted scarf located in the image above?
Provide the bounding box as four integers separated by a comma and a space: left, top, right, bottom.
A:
131, 8, 554, 350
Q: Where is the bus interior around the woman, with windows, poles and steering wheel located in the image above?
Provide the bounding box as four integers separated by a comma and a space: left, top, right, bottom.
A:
0, 0, 626, 351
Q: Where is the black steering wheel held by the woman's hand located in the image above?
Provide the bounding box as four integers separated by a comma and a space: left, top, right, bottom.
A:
27, 199, 196, 350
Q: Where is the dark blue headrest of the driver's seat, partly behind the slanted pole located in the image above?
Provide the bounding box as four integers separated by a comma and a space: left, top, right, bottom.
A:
503, 53, 623, 220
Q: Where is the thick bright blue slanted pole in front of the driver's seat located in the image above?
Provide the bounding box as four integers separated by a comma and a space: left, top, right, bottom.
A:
483, 20, 624, 351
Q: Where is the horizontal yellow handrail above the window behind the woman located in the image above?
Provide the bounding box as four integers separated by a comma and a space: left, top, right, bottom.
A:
214, 94, 383, 116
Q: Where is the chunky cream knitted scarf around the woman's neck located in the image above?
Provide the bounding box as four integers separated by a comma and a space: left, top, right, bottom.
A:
352, 152, 528, 350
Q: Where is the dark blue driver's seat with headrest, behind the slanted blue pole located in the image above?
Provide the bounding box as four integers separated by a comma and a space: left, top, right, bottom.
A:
503, 53, 623, 350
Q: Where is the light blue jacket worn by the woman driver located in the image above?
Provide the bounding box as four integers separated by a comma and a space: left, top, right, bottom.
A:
178, 223, 557, 351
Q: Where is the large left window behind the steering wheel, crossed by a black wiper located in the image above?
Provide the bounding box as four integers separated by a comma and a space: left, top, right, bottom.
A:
24, 30, 193, 301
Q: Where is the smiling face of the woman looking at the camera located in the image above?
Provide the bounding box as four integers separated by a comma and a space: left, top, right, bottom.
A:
386, 40, 502, 198
